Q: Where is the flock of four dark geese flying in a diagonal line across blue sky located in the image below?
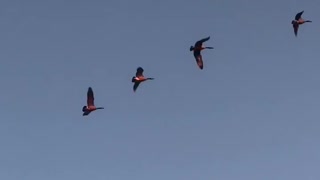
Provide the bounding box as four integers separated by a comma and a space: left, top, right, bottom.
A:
82, 11, 312, 116
